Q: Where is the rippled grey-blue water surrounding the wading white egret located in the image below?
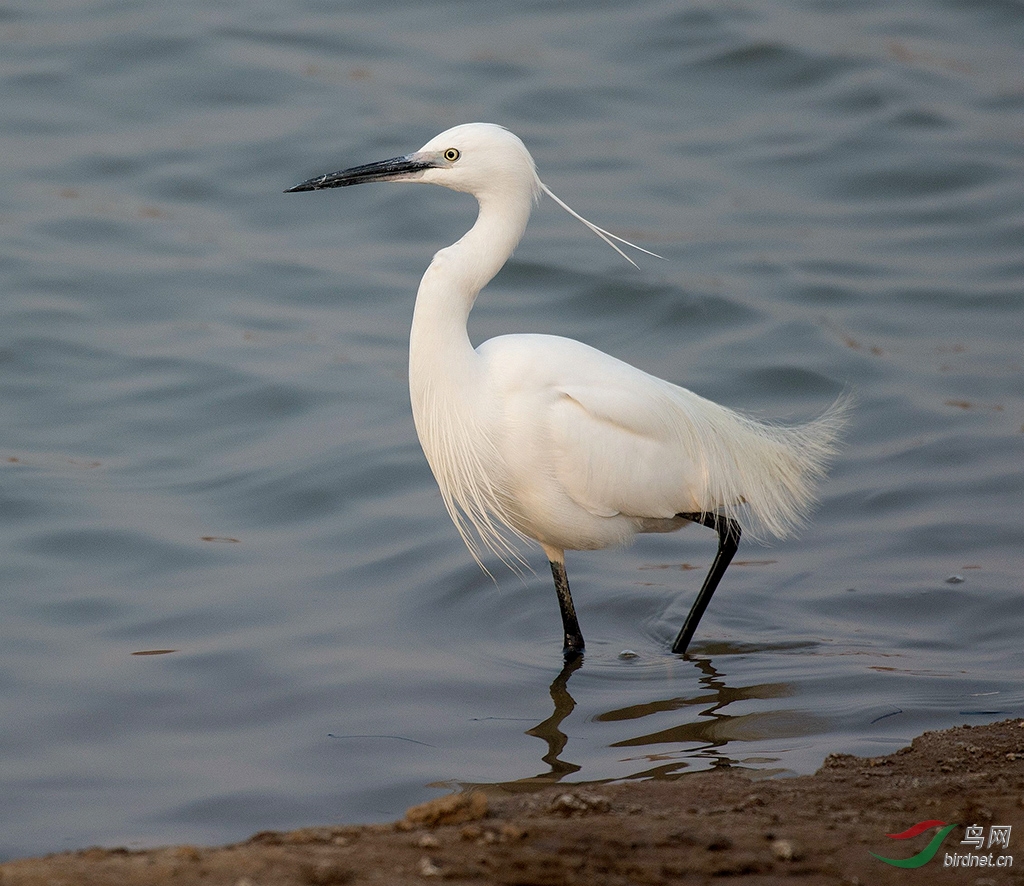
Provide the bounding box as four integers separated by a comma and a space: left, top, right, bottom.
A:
0, 0, 1024, 856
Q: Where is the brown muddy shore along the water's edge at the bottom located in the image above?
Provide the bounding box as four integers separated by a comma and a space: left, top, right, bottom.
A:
0, 719, 1024, 886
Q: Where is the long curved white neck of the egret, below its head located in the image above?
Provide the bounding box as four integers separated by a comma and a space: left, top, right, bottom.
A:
409, 195, 532, 387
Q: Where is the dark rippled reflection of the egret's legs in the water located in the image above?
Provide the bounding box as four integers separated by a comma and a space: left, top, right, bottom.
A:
516, 657, 826, 787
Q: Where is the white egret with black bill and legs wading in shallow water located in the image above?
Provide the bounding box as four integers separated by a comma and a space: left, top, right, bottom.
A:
285, 123, 848, 662
